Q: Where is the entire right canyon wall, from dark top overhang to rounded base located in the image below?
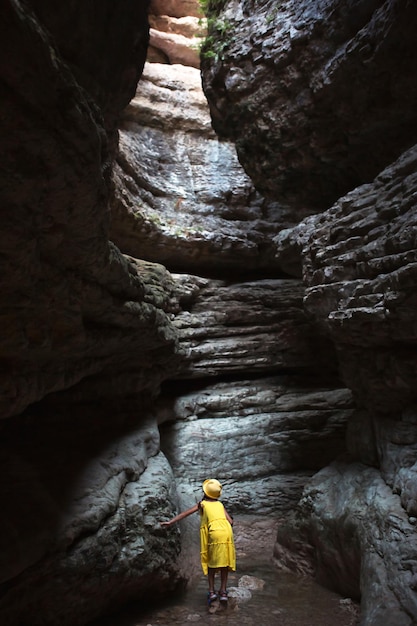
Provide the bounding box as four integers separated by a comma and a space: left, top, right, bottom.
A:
197, 2, 417, 625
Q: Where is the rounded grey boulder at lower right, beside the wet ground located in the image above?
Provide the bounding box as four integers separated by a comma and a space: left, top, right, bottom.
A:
275, 460, 417, 625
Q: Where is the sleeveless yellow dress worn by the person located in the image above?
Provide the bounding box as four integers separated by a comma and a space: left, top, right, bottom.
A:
200, 500, 236, 575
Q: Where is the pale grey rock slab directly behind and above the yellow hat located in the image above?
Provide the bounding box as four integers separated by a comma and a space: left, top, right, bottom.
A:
157, 375, 353, 516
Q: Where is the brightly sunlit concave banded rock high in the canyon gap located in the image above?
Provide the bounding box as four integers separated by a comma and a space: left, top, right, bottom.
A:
111, 64, 293, 273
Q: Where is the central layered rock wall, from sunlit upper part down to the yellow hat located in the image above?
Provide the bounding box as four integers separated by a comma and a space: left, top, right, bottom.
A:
111, 0, 353, 528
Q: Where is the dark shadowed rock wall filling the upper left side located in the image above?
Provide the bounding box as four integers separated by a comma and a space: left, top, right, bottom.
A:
1, 2, 176, 417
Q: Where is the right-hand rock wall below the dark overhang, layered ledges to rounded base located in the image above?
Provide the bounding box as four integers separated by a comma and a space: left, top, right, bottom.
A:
276, 148, 417, 624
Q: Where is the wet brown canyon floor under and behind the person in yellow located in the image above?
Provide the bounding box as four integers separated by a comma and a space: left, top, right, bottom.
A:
94, 516, 359, 626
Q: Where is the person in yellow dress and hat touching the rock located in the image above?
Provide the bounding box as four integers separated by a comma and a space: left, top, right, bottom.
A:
161, 478, 236, 605
